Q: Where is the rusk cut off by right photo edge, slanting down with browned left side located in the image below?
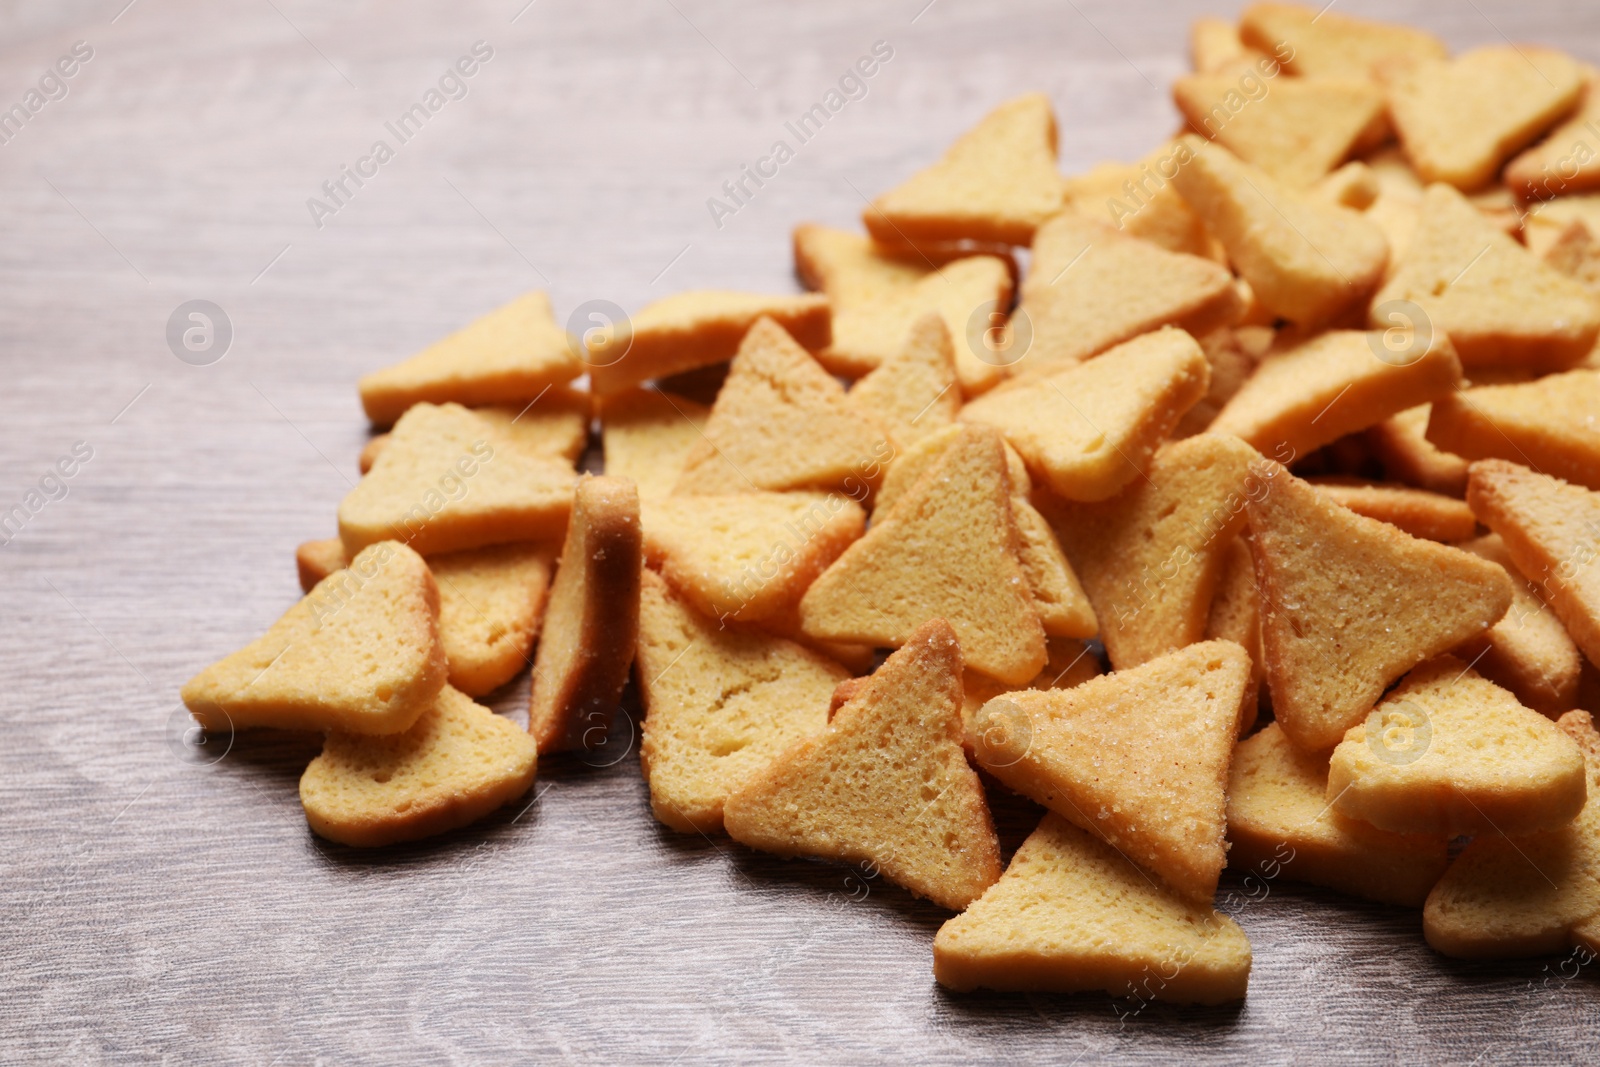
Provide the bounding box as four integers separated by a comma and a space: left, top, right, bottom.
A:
1467, 459, 1600, 664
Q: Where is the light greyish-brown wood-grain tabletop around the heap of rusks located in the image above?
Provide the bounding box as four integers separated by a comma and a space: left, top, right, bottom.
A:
0, 0, 1600, 1065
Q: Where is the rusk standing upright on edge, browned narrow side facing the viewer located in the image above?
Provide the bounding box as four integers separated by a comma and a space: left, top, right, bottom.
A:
528, 475, 643, 752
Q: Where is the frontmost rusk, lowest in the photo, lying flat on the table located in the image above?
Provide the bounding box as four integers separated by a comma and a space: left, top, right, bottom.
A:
933, 813, 1250, 1005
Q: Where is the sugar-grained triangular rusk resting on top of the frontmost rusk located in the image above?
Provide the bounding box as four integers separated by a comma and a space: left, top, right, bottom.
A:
973, 641, 1254, 901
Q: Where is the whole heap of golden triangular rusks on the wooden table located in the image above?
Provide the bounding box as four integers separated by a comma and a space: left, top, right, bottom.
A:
184, 3, 1600, 1003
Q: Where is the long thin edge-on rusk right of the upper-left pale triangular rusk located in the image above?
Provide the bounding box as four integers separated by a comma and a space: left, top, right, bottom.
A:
586, 290, 832, 397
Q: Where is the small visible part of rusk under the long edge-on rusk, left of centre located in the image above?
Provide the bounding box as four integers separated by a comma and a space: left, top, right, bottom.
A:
600, 389, 710, 501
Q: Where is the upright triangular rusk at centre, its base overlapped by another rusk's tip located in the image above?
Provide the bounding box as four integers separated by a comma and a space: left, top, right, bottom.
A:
800, 427, 1045, 685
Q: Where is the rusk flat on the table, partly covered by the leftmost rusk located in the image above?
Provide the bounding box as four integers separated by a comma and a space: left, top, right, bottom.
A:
301, 685, 538, 848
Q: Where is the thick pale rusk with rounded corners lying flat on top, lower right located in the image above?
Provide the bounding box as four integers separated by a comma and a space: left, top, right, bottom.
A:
1326, 656, 1586, 837
